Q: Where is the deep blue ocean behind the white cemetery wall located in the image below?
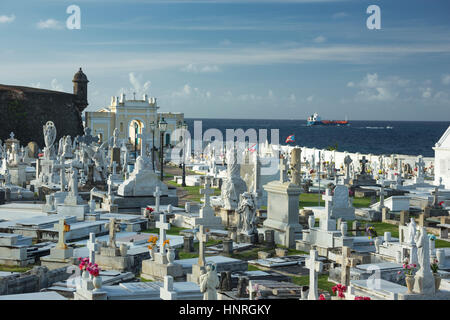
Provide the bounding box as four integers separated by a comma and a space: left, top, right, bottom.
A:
186, 119, 450, 157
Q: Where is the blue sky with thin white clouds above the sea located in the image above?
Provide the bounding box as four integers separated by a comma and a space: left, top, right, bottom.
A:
0, 0, 450, 121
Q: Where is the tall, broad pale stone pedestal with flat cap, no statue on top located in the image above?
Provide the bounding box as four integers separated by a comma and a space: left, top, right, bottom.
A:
263, 181, 302, 248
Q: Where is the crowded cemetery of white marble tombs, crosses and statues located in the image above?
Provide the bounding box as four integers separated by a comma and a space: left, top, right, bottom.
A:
0, 115, 450, 303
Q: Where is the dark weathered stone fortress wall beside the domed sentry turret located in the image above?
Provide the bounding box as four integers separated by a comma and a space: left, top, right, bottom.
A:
0, 85, 83, 148
